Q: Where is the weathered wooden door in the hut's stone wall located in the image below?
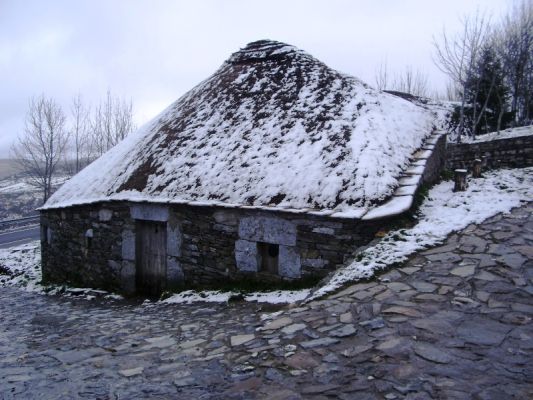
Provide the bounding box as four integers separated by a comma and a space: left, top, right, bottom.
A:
135, 221, 167, 296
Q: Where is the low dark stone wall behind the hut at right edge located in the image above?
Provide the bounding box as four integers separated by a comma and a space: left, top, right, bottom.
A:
446, 136, 533, 170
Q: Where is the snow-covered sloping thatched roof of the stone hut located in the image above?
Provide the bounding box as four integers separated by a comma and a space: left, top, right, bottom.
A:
43, 41, 434, 217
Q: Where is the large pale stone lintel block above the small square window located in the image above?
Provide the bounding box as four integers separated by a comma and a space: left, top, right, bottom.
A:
239, 216, 296, 246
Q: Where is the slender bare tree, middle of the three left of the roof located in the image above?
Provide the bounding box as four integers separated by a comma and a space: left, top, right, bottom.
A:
70, 93, 92, 173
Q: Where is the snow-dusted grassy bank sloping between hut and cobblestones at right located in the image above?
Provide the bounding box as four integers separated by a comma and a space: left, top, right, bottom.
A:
307, 168, 533, 300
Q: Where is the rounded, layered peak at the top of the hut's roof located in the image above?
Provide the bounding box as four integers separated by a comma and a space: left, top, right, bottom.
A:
228, 39, 304, 64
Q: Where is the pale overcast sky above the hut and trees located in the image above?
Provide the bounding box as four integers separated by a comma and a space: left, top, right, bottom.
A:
0, 0, 513, 157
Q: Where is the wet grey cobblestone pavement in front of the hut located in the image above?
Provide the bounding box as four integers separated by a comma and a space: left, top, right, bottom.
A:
0, 203, 533, 399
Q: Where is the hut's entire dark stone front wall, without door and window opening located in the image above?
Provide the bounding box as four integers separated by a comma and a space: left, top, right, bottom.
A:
41, 202, 390, 293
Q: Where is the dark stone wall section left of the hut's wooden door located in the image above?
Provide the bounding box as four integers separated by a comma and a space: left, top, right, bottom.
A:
41, 203, 135, 290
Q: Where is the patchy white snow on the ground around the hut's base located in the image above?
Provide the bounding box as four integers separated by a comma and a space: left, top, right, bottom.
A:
0, 167, 533, 305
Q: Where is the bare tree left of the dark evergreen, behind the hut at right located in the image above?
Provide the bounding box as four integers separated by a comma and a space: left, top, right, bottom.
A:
433, 12, 489, 138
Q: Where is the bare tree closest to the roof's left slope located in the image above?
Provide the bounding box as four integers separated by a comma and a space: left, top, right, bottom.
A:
91, 90, 134, 155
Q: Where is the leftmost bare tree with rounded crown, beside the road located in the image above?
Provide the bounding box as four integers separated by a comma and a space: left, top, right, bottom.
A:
12, 95, 68, 203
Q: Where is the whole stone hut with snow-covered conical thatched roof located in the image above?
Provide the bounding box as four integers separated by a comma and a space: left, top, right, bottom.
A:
40, 41, 442, 295
